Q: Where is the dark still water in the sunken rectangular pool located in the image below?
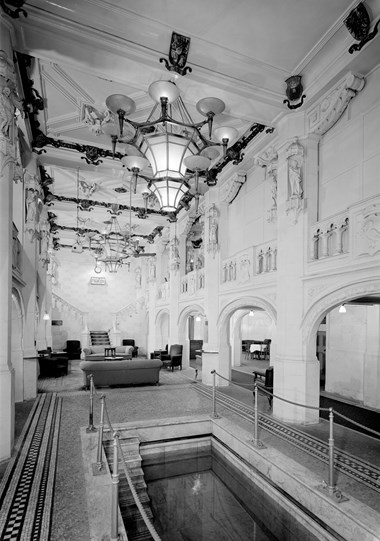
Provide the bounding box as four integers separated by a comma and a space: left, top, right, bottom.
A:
143, 442, 325, 541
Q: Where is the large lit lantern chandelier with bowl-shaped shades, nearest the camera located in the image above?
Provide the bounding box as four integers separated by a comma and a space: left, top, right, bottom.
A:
102, 33, 242, 212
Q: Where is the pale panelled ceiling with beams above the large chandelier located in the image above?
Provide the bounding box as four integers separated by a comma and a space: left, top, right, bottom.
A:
10, 0, 380, 255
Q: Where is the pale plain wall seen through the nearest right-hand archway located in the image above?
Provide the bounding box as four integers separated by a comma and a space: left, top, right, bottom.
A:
325, 305, 368, 402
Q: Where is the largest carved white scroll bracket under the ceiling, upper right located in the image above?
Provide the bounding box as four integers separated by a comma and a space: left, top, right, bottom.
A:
307, 72, 365, 136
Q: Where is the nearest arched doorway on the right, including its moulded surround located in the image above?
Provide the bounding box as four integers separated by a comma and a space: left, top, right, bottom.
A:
303, 282, 380, 410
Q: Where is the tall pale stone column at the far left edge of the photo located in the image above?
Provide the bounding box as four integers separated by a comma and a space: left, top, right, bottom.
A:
0, 17, 16, 461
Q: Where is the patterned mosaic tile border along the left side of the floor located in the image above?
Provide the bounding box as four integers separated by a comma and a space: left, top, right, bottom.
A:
0, 393, 62, 541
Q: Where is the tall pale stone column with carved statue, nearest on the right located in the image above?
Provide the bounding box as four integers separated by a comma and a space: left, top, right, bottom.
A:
272, 119, 319, 423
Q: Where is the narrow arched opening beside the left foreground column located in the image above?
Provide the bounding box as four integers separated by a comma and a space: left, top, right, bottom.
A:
11, 287, 24, 402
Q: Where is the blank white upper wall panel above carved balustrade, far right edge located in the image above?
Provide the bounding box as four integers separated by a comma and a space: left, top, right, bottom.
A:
319, 68, 380, 220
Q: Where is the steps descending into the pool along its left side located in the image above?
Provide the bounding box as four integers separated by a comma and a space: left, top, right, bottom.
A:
104, 437, 153, 541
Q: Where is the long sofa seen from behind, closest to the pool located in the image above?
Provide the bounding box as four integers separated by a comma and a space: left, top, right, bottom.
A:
79, 359, 162, 387
